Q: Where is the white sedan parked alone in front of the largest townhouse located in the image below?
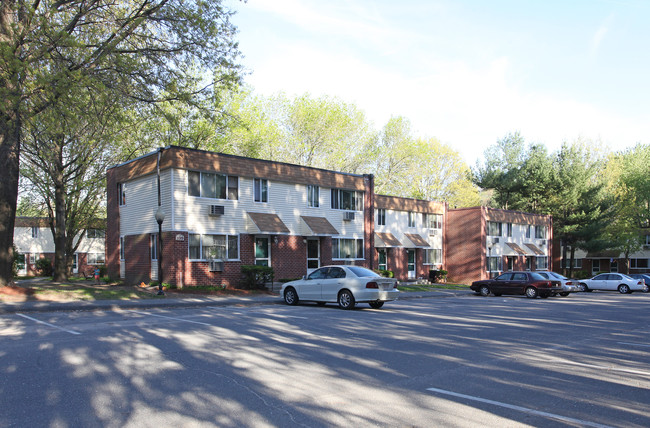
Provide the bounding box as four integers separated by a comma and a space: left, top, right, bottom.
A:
280, 265, 399, 309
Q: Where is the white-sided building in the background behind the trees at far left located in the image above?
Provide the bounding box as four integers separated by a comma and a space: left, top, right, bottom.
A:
14, 217, 105, 275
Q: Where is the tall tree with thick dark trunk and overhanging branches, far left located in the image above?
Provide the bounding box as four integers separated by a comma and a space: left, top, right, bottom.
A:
0, 0, 238, 285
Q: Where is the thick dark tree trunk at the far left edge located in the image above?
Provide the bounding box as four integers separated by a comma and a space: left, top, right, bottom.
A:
0, 110, 21, 286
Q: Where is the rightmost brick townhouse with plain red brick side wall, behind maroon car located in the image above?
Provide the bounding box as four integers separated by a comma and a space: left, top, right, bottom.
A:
446, 207, 553, 284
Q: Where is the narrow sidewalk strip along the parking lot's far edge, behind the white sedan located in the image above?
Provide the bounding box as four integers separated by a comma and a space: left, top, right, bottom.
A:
0, 289, 473, 315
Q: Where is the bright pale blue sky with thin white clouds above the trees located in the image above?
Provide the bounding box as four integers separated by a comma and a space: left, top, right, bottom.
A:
225, 0, 650, 166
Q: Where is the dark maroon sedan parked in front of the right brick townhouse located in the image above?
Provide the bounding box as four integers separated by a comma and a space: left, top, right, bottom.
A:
469, 272, 562, 299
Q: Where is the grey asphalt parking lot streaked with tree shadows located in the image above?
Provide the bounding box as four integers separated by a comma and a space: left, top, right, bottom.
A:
0, 292, 650, 428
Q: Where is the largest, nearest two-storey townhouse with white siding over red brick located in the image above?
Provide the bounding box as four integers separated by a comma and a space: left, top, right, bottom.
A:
106, 146, 376, 286
